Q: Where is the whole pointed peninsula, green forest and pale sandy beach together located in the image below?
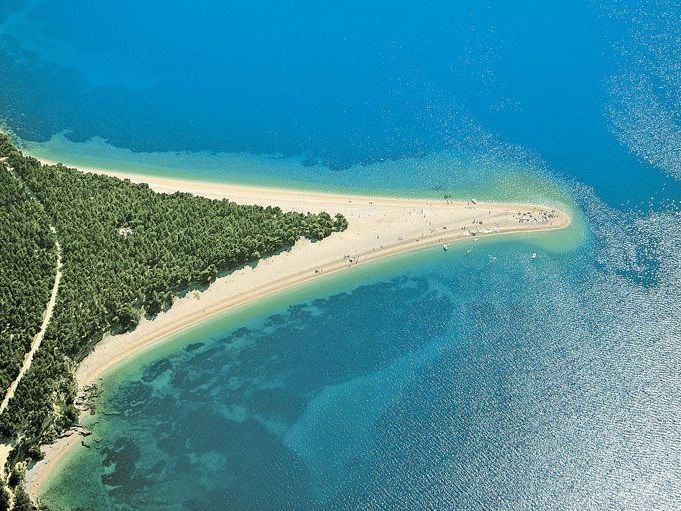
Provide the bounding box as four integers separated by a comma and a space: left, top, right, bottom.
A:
0, 135, 570, 510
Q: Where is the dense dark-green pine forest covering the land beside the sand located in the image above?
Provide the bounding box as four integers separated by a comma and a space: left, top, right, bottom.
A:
0, 134, 347, 504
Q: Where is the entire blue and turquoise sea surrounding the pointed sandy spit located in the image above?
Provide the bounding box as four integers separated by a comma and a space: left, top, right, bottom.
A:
0, 0, 681, 510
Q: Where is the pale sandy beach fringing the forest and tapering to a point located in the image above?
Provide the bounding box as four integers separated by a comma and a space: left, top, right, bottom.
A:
26, 164, 571, 498
